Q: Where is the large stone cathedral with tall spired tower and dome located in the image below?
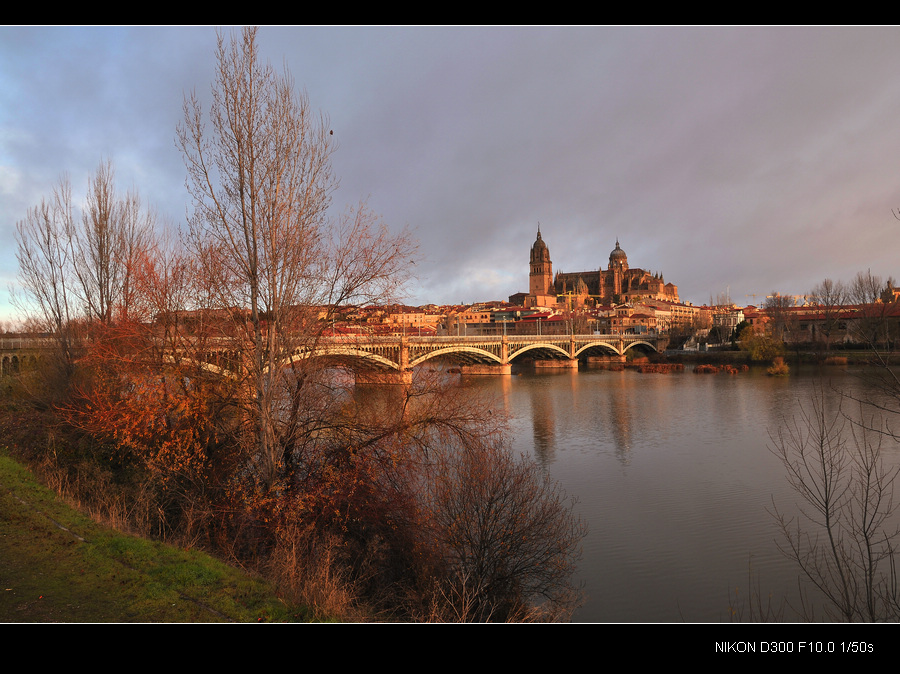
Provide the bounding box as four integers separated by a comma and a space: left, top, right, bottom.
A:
525, 225, 678, 309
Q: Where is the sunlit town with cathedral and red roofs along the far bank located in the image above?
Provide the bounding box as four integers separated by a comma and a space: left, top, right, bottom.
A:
321, 228, 900, 351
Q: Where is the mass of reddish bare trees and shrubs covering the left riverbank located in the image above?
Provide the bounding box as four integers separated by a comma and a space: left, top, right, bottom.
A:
5, 28, 585, 621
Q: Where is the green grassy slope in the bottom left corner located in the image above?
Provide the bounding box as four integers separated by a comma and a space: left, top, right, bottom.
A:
0, 450, 316, 623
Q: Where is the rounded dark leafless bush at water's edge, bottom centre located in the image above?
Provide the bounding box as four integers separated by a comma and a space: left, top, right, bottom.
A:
426, 443, 587, 621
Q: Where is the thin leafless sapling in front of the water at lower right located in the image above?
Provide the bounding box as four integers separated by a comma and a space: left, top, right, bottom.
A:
770, 392, 900, 622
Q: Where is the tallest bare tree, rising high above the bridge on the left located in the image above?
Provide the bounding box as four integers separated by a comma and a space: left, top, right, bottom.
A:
178, 28, 412, 488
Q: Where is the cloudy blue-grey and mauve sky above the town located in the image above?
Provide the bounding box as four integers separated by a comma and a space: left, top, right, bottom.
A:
0, 26, 900, 320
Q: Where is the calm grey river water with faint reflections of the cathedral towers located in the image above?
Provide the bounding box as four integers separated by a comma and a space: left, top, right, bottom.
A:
466, 368, 896, 622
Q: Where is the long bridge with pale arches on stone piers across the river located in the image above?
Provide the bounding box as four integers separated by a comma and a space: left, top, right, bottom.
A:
0, 335, 668, 382
